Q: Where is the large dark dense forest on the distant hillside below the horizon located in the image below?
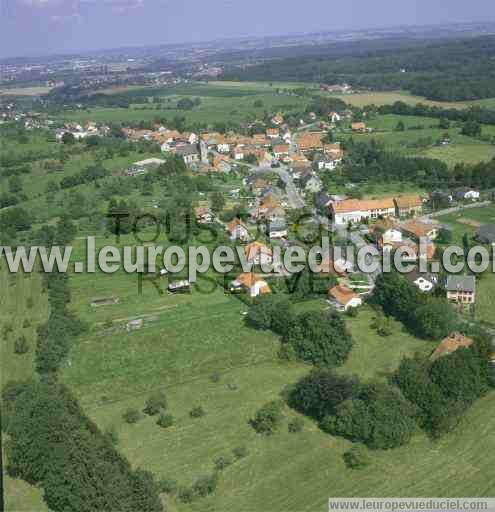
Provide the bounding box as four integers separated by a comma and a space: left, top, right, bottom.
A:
224, 36, 495, 101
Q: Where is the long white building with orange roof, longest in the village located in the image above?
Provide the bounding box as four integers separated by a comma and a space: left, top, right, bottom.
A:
330, 198, 395, 224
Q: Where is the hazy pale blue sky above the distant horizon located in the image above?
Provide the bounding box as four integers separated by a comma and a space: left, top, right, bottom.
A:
0, 0, 495, 58
